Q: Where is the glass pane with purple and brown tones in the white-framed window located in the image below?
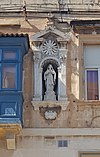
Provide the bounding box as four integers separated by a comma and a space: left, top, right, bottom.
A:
87, 70, 99, 100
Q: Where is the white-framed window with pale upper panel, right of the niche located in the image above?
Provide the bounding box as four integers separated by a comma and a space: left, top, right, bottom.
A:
84, 45, 100, 100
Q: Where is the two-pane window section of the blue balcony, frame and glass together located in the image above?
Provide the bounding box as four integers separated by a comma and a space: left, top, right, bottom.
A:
0, 48, 20, 90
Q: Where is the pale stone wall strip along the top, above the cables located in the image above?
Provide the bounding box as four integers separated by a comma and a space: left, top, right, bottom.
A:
0, 0, 100, 12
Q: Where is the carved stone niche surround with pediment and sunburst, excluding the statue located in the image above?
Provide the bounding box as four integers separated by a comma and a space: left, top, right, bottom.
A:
31, 27, 70, 114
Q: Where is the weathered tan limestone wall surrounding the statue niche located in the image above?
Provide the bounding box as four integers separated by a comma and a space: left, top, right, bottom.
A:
0, 6, 100, 128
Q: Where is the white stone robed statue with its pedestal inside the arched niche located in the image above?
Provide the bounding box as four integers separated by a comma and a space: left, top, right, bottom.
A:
44, 64, 56, 100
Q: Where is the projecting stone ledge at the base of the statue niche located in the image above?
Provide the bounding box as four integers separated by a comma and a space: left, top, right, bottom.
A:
31, 100, 69, 111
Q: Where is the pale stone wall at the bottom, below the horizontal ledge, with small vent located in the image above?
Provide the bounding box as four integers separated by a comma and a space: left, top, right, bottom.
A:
0, 129, 100, 157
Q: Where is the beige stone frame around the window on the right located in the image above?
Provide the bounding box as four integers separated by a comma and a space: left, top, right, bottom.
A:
78, 34, 100, 101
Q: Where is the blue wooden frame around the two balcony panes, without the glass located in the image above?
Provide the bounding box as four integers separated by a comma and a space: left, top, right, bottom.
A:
0, 45, 21, 91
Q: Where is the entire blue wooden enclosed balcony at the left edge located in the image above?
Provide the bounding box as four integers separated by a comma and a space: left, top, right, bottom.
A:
0, 35, 29, 121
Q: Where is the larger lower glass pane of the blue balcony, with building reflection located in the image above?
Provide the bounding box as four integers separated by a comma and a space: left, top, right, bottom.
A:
2, 65, 16, 88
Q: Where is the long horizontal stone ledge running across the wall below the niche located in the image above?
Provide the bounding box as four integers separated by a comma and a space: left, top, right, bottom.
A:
22, 128, 100, 136
